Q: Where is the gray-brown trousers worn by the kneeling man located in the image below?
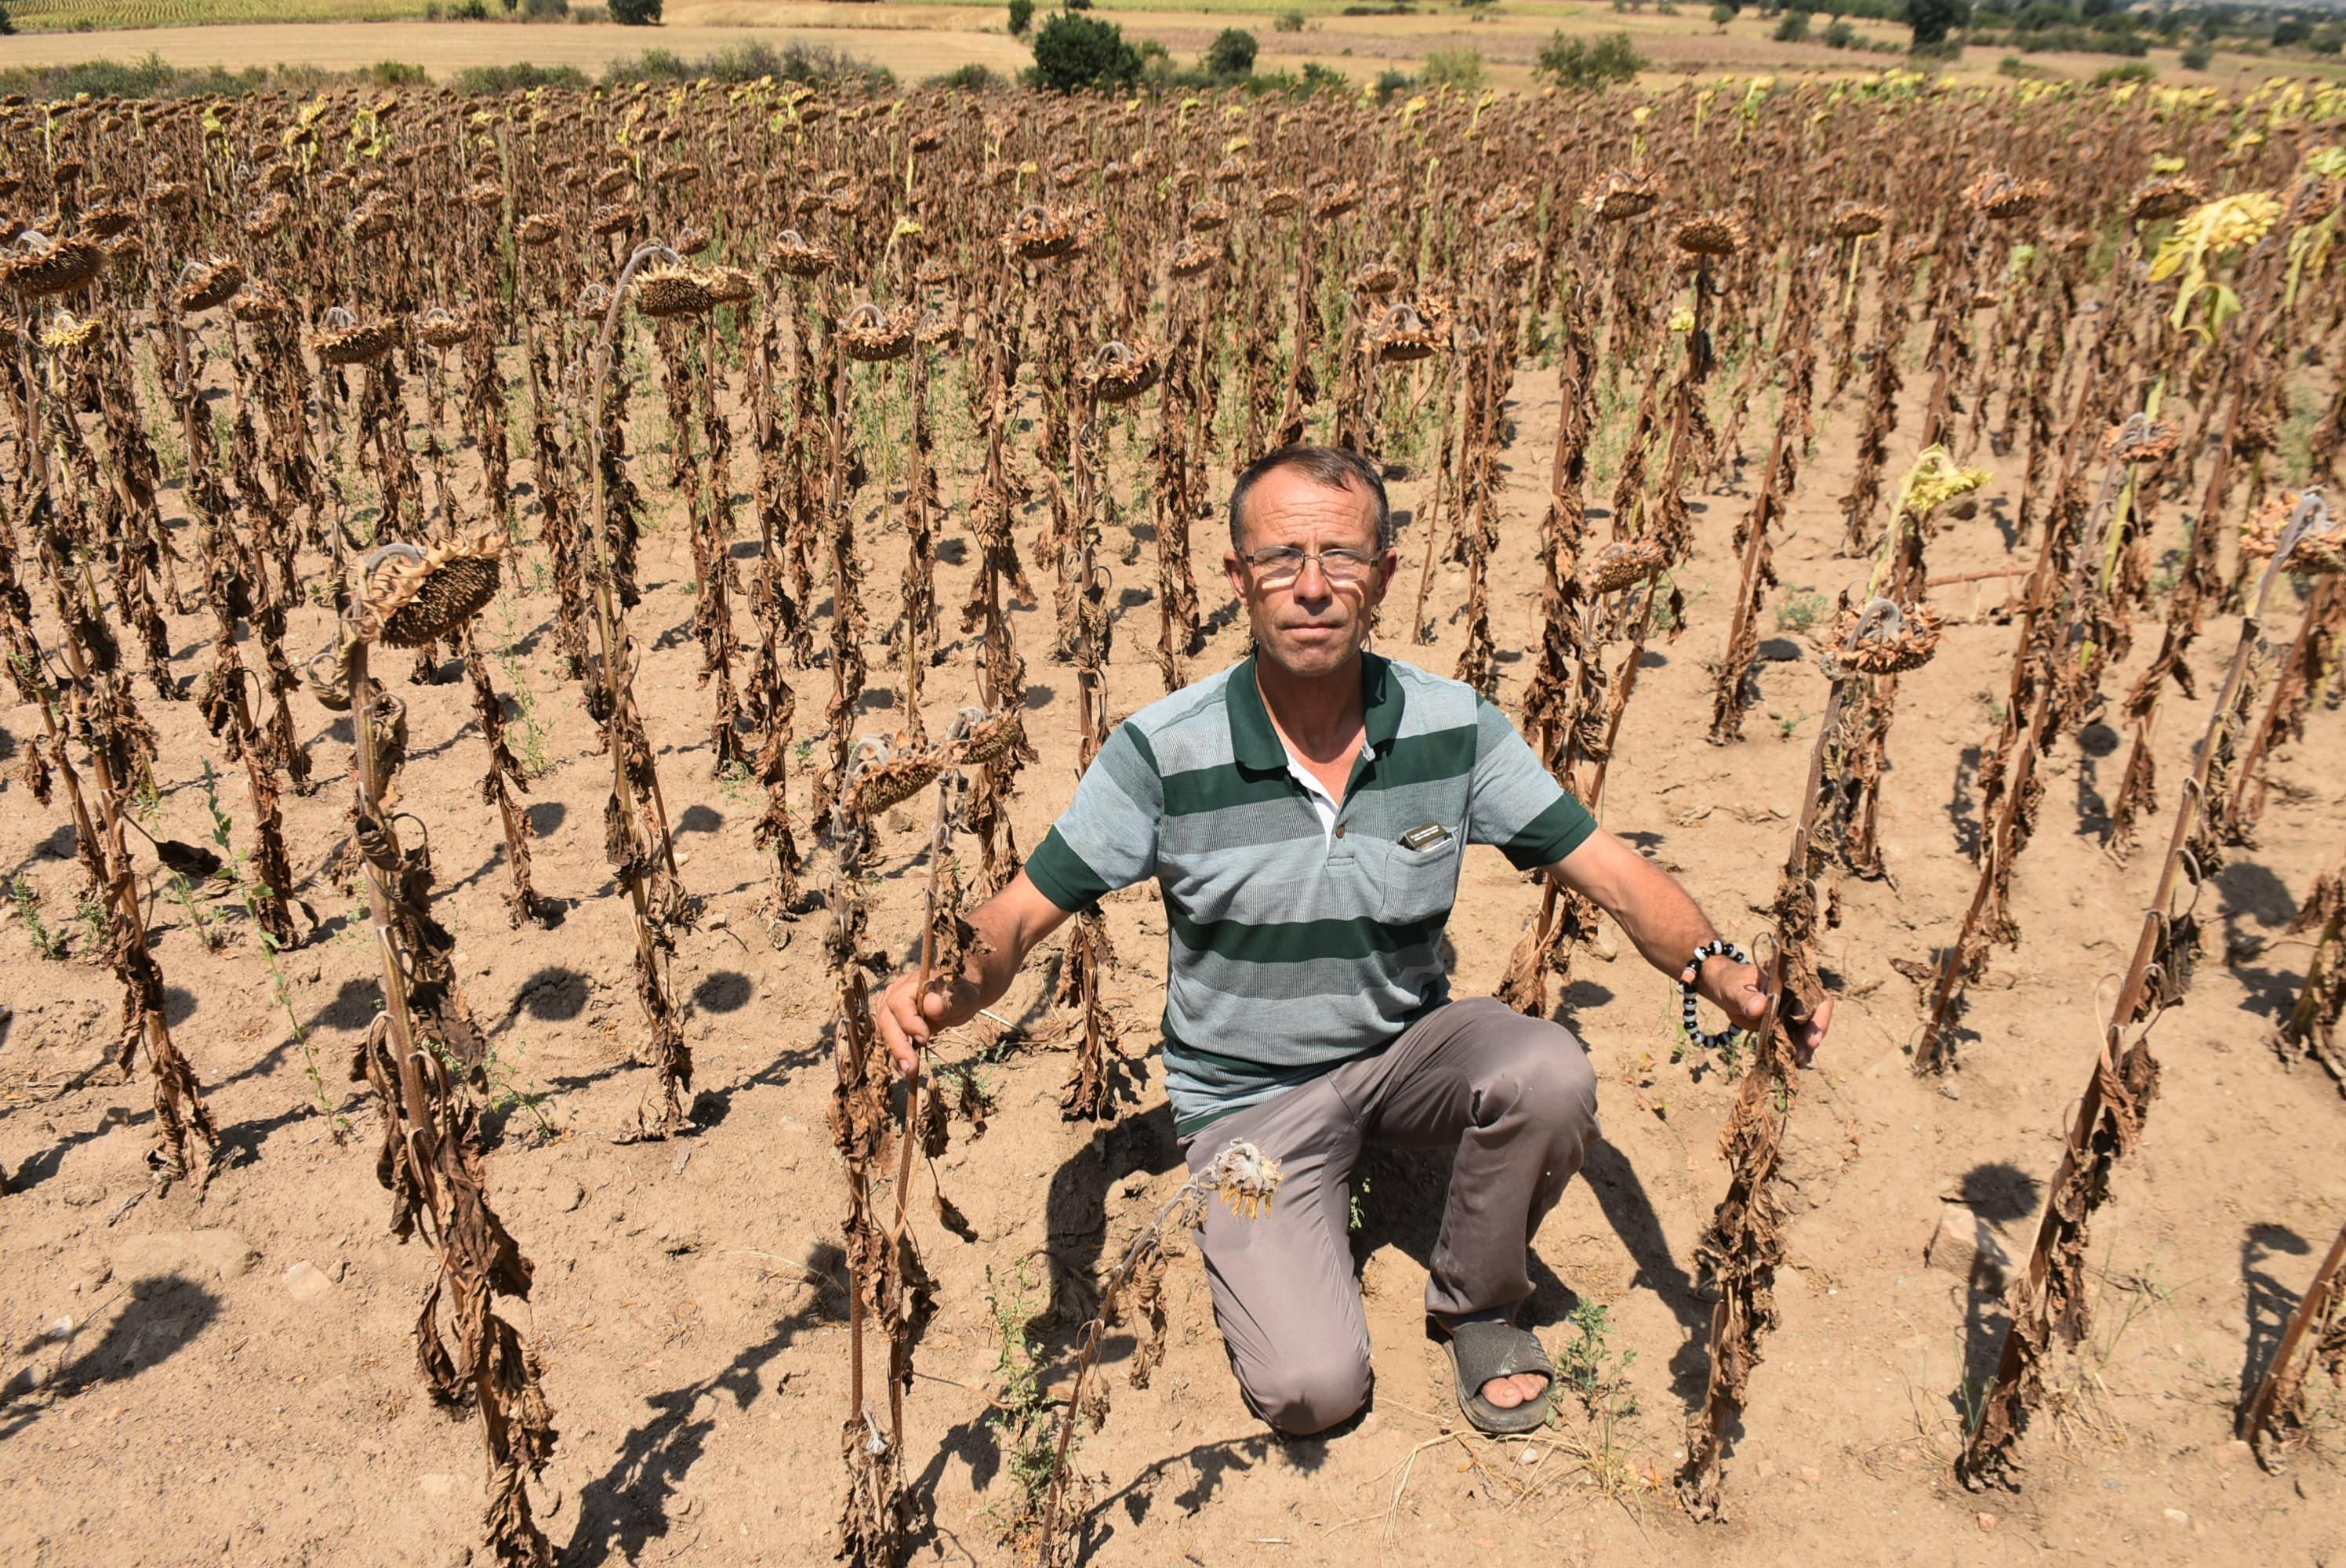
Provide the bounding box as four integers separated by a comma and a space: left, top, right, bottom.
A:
1182, 997, 1598, 1436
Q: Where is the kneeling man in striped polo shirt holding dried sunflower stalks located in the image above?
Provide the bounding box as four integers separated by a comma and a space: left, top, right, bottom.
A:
877, 446, 1830, 1434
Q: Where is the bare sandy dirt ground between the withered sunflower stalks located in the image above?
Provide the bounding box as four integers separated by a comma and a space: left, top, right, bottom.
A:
0, 305, 2346, 1568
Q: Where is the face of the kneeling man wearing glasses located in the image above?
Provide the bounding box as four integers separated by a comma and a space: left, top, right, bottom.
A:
1222, 470, 1398, 676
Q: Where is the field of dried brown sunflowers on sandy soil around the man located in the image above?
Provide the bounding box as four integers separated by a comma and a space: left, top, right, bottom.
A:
0, 75, 2346, 1568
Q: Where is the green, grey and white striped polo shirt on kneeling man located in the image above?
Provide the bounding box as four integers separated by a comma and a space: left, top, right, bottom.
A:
1026, 652, 1596, 1138
